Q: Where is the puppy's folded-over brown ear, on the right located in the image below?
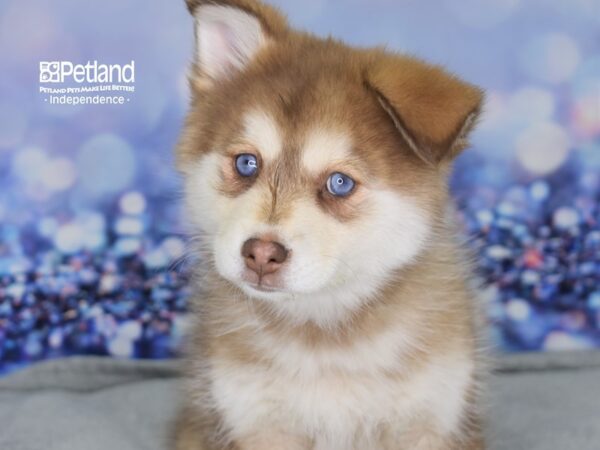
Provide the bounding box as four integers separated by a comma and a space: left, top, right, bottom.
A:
366, 54, 483, 165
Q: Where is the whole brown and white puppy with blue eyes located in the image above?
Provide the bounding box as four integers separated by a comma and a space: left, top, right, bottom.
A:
173, 0, 484, 450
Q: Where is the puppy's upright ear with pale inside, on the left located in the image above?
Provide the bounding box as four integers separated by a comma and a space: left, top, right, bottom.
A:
186, 0, 288, 90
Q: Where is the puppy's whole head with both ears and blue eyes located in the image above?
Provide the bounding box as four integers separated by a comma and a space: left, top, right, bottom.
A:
177, 0, 481, 323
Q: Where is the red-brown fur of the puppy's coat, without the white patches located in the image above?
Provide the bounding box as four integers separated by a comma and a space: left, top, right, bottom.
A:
173, 0, 484, 450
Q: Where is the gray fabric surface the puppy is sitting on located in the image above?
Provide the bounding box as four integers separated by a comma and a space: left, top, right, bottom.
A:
0, 353, 600, 450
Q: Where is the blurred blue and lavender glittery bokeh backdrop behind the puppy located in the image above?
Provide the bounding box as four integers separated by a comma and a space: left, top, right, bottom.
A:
0, 0, 600, 371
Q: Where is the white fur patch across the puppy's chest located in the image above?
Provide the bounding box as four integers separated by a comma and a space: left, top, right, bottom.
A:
202, 331, 473, 450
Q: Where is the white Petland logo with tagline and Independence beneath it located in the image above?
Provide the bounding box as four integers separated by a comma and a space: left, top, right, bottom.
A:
39, 60, 135, 105
